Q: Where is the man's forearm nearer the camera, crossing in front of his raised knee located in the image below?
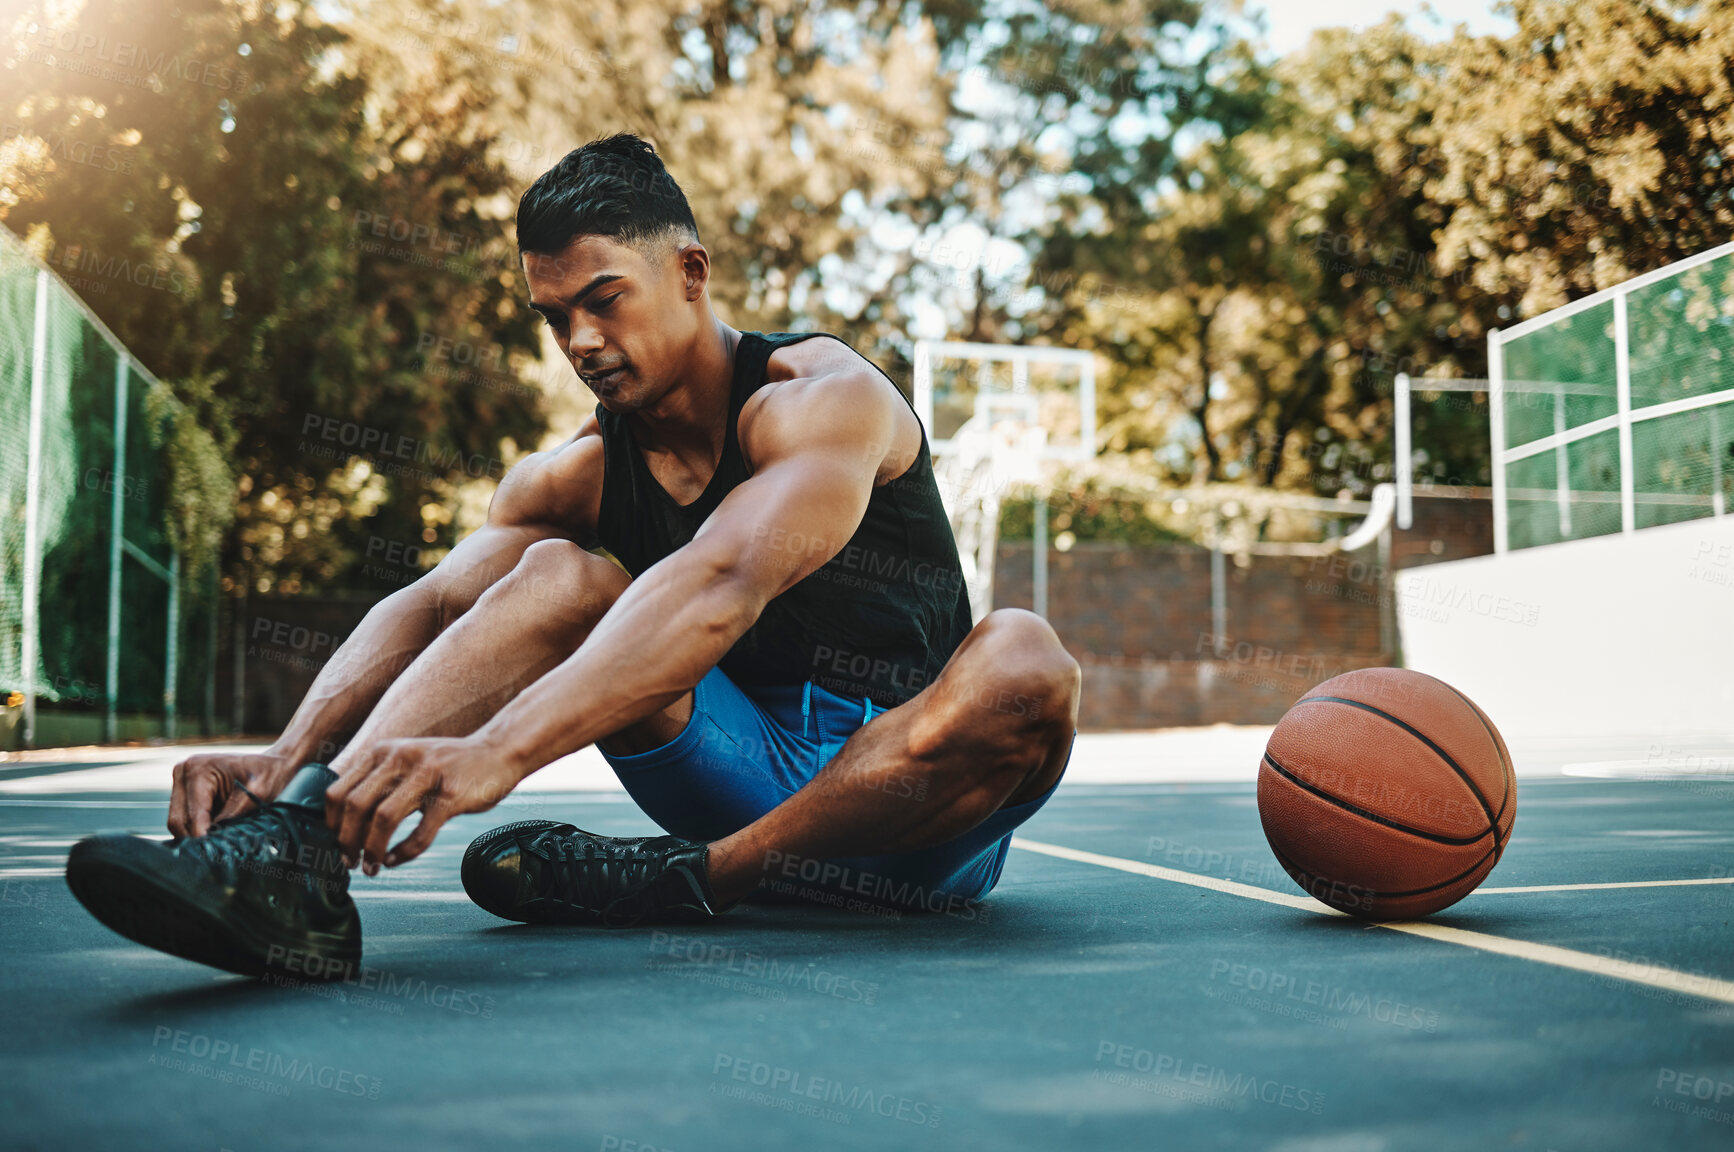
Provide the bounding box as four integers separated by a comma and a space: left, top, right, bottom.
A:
473, 553, 763, 776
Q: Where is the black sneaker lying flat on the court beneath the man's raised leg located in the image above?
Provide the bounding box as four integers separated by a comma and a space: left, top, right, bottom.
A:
463, 821, 720, 928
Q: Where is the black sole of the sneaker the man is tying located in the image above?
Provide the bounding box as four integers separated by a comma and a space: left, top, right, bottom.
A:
66, 841, 361, 980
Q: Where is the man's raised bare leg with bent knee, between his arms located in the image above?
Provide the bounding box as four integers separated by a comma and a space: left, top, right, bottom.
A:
331, 540, 692, 776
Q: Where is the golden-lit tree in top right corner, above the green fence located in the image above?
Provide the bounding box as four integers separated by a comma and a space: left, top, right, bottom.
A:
1434, 0, 1734, 316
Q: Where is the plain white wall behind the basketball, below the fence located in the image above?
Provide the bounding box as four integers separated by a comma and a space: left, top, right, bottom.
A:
1398, 515, 1734, 737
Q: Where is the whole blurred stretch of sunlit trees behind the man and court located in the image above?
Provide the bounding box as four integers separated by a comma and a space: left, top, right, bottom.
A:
0, 0, 1734, 576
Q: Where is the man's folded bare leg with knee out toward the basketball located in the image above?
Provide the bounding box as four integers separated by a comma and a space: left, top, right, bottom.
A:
709, 609, 1080, 904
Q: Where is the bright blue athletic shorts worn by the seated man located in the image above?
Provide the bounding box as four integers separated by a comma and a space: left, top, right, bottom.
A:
603, 668, 1059, 911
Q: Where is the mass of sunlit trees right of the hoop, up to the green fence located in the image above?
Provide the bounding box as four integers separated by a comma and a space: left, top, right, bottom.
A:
1025, 0, 1734, 510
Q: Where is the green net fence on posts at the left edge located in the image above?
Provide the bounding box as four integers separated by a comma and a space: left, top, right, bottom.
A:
0, 229, 215, 746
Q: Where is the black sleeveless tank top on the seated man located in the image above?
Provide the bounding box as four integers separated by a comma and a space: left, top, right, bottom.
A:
596, 331, 969, 708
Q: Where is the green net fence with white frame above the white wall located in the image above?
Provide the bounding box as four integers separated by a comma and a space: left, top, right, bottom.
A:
1490, 245, 1734, 548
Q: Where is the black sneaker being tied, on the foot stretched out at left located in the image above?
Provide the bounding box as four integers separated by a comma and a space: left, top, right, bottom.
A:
66, 763, 361, 980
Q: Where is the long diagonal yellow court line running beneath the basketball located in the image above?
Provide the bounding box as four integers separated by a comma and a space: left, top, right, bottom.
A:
1011, 836, 1734, 1005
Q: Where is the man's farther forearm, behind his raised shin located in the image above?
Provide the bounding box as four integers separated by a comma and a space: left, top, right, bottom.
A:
271, 586, 440, 762
